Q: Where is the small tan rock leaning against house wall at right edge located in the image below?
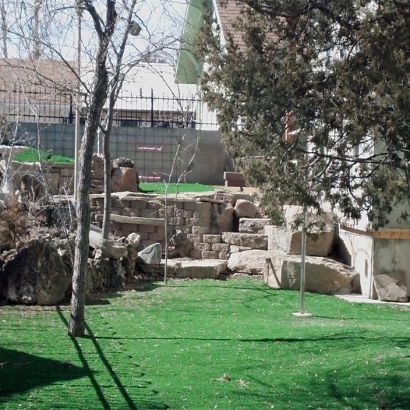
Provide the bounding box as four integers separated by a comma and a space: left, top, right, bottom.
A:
373, 271, 408, 302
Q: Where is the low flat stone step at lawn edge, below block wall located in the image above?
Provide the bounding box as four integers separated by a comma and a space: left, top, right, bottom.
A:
139, 259, 227, 279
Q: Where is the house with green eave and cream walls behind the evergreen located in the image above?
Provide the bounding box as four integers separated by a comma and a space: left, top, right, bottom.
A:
176, 0, 410, 298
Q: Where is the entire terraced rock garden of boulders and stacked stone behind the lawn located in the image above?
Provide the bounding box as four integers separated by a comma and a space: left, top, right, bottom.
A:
0, 149, 366, 305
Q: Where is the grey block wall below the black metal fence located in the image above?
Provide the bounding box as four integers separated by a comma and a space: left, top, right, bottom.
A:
14, 123, 233, 185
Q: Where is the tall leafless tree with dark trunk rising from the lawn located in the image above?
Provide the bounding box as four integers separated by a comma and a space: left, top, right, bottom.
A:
0, 0, 184, 337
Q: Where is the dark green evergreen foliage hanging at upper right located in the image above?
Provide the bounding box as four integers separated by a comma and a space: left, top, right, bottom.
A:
198, 0, 410, 228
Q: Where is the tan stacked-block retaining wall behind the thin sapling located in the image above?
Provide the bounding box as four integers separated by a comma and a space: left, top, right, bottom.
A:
90, 192, 267, 259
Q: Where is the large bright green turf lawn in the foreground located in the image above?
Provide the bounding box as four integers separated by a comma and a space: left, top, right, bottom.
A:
0, 278, 410, 410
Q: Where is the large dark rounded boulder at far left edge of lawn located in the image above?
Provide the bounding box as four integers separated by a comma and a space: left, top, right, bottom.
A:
1, 239, 71, 305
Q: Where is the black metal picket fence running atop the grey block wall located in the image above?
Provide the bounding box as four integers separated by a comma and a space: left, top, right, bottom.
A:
0, 86, 218, 130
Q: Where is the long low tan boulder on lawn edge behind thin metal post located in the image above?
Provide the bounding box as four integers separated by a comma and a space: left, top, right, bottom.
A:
264, 252, 356, 294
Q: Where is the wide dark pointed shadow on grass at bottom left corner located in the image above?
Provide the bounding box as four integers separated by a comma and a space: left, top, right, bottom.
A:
0, 347, 88, 402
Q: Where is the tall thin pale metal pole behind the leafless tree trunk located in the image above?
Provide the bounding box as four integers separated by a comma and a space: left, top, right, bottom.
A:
74, 0, 81, 205
